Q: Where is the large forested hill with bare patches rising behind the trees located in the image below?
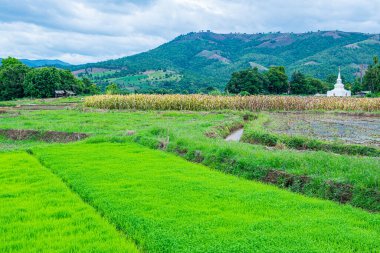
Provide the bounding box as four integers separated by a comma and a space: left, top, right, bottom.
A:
73, 31, 380, 91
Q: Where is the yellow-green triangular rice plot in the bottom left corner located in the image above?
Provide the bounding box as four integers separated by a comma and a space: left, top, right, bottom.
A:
0, 152, 138, 252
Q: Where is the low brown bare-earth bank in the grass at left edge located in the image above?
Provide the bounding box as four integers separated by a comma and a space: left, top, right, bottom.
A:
0, 129, 88, 142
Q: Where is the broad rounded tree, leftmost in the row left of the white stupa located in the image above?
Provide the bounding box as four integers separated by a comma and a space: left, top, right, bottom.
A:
225, 68, 269, 94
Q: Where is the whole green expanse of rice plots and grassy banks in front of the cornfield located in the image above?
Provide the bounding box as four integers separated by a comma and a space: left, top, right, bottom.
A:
0, 97, 380, 252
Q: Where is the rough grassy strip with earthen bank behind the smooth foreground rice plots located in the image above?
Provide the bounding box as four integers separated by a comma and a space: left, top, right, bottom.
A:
0, 110, 380, 211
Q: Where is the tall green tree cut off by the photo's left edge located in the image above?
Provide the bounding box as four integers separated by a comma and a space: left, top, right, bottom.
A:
0, 57, 29, 100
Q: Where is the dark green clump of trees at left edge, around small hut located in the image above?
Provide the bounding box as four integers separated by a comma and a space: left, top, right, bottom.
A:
0, 57, 100, 100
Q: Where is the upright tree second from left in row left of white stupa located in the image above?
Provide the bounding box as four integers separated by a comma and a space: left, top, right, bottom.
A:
266, 66, 288, 94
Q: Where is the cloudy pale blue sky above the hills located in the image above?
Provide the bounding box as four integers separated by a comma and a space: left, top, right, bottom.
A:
0, 0, 380, 64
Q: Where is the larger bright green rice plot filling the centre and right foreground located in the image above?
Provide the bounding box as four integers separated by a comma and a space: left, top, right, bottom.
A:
33, 143, 380, 252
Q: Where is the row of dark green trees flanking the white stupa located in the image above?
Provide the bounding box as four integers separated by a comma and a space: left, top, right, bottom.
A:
225, 57, 380, 95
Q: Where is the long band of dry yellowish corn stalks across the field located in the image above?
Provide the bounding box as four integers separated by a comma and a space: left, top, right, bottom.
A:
85, 94, 380, 112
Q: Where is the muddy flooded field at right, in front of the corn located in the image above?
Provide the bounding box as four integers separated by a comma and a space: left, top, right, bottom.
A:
266, 112, 380, 147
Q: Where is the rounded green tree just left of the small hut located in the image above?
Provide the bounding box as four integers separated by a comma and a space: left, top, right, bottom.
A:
24, 67, 62, 98
